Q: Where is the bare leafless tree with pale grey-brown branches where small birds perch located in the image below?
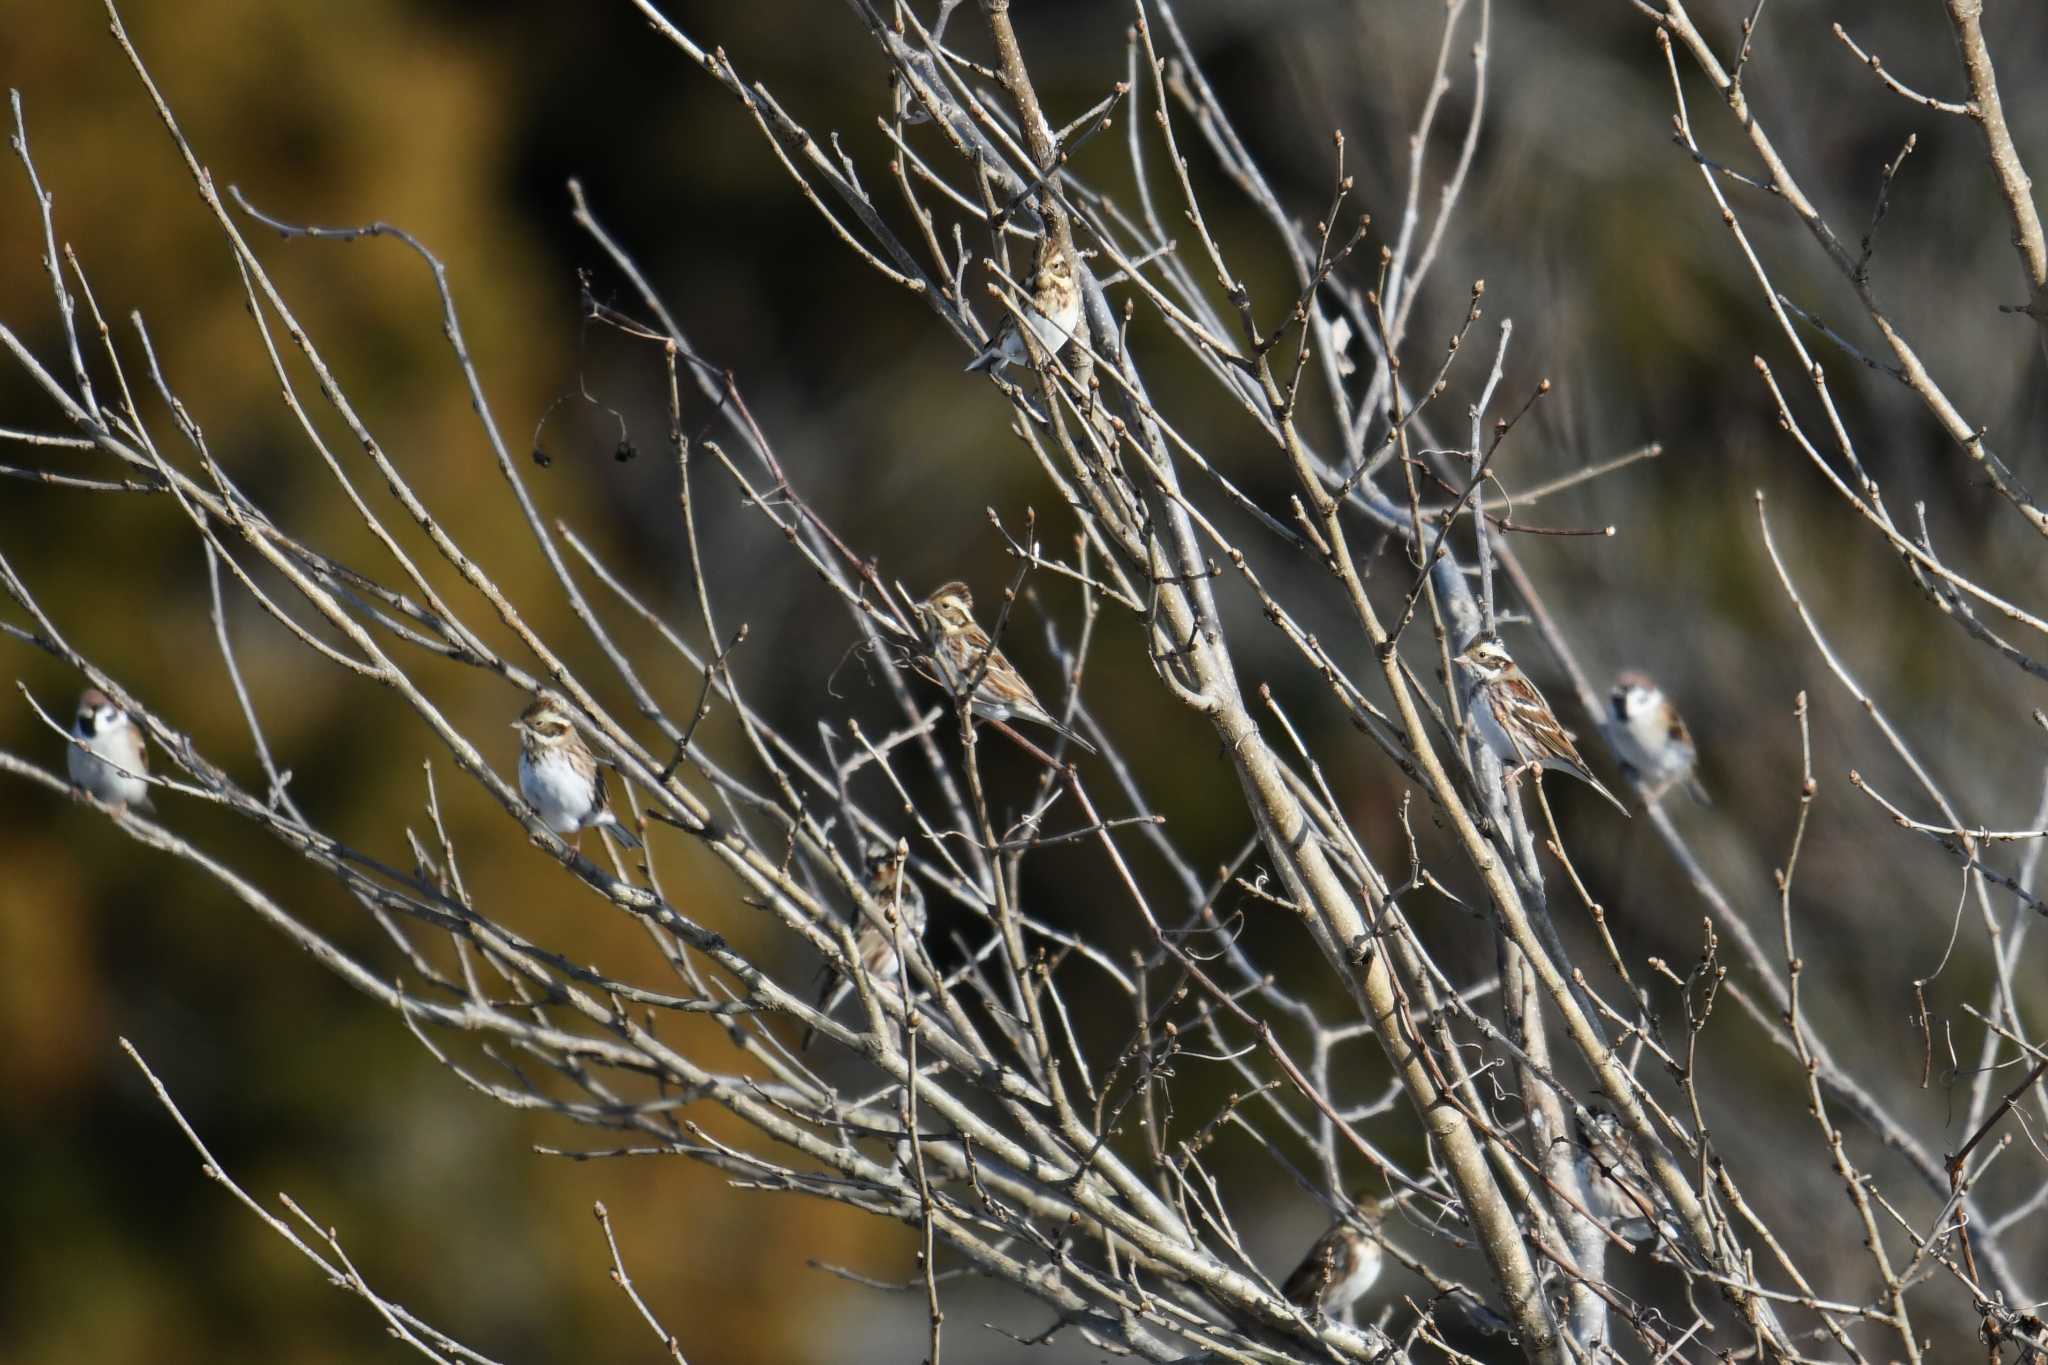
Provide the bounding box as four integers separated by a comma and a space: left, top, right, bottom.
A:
0, 0, 2048, 1361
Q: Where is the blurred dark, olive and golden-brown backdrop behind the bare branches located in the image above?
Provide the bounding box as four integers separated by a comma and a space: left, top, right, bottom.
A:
0, 0, 2048, 1365
